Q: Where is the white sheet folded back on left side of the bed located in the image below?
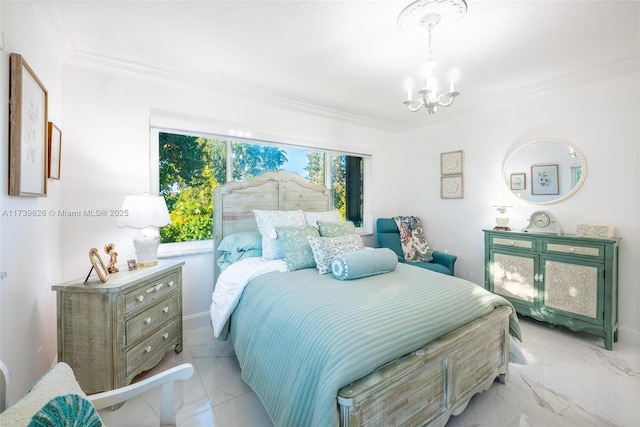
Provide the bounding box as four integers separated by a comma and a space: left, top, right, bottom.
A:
210, 257, 287, 338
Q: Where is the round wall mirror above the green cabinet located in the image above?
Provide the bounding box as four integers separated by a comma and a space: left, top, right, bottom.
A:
502, 138, 587, 205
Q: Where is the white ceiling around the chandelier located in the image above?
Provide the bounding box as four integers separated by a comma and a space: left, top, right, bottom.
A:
34, 0, 640, 128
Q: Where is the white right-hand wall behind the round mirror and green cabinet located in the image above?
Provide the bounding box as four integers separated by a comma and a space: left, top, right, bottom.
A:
398, 65, 640, 341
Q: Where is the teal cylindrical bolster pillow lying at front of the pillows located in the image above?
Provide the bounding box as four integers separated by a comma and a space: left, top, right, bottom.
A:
331, 248, 398, 280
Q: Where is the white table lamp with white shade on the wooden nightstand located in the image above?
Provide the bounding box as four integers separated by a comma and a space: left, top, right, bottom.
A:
116, 194, 171, 267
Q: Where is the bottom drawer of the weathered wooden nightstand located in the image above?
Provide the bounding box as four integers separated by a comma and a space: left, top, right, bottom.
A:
126, 319, 181, 377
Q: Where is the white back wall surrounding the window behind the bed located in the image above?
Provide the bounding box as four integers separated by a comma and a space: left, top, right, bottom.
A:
61, 65, 396, 327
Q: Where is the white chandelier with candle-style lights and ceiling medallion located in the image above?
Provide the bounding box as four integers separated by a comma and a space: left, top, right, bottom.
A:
397, 0, 467, 114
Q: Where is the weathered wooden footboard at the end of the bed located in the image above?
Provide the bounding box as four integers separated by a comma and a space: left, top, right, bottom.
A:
338, 307, 511, 427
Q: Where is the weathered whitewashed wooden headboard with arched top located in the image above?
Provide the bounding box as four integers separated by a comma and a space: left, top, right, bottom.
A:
213, 171, 333, 280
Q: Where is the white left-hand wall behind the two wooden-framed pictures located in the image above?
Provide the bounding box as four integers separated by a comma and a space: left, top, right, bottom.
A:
0, 2, 64, 401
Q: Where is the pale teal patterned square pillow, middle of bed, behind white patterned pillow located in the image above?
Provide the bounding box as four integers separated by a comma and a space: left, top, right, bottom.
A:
276, 225, 319, 271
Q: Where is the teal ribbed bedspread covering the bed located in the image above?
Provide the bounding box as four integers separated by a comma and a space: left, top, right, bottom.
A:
230, 264, 520, 427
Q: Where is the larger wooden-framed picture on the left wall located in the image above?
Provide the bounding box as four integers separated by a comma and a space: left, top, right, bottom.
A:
9, 53, 48, 197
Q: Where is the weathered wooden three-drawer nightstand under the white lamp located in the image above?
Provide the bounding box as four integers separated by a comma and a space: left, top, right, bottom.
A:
51, 260, 184, 394
